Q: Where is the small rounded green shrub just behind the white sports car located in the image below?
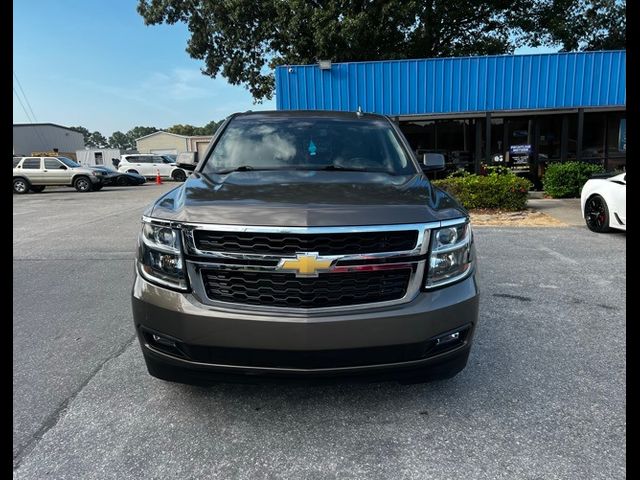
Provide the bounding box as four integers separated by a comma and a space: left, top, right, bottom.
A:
542, 162, 604, 198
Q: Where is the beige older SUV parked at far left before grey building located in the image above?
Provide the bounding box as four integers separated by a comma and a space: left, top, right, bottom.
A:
13, 157, 104, 194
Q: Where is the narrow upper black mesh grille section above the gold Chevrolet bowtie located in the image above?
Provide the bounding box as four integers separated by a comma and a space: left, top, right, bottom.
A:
193, 230, 418, 255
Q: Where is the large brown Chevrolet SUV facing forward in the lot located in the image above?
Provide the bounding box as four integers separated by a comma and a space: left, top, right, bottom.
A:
132, 111, 479, 383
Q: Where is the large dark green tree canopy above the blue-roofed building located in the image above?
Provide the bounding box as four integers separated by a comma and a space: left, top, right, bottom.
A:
137, 0, 626, 101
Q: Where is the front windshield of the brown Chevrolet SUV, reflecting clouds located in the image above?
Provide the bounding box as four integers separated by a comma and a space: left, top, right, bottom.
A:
202, 116, 416, 175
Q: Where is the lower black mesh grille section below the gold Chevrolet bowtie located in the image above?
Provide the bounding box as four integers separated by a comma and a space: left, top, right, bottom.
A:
202, 268, 411, 308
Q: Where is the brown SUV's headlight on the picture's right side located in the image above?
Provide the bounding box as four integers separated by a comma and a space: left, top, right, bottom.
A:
425, 222, 474, 289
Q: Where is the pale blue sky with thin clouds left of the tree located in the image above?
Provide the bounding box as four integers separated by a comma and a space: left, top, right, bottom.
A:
13, 0, 553, 136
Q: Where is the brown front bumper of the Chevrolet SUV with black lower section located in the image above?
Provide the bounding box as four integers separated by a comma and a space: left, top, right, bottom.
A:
132, 271, 478, 383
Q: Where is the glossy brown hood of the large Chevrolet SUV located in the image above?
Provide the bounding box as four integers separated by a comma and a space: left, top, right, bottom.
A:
147, 171, 467, 227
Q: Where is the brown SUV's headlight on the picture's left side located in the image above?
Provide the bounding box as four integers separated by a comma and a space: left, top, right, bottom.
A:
138, 222, 187, 290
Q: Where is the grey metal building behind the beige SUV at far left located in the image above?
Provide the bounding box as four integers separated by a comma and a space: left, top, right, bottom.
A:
13, 123, 84, 156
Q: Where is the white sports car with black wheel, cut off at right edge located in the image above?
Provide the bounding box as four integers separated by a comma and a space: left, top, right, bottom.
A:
580, 173, 627, 233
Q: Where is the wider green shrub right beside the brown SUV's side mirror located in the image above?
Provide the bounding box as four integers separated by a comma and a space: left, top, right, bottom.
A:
432, 172, 532, 211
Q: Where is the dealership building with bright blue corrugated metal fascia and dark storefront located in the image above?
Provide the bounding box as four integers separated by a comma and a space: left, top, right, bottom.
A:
275, 50, 626, 183
